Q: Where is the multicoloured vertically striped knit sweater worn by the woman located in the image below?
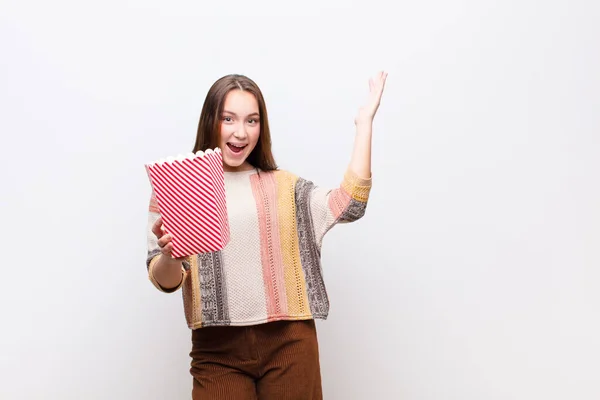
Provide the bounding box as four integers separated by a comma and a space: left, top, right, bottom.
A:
146, 170, 371, 329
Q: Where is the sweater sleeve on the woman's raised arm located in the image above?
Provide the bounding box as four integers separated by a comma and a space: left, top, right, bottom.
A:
296, 170, 372, 247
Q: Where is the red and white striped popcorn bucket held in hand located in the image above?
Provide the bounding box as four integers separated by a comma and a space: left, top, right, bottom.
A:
146, 148, 229, 258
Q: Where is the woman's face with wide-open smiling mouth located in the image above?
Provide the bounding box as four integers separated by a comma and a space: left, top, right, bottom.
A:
219, 89, 260, 172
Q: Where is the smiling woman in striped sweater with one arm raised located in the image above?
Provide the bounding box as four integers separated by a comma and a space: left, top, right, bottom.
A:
147, 72, 387, 400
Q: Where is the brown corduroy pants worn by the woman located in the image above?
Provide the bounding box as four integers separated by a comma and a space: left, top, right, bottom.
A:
190, 320, 323, 400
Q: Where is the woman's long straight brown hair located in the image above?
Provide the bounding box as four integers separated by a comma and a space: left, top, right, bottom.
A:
194, 74, 277, 171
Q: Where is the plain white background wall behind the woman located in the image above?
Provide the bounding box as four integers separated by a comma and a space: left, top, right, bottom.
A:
0, 0, 600, 400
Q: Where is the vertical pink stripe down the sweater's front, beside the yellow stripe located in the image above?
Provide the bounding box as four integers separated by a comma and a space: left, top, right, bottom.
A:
250, 173, 288, 320
